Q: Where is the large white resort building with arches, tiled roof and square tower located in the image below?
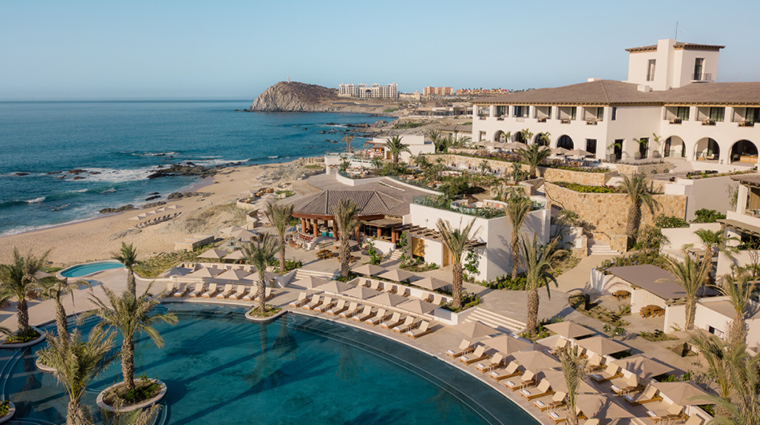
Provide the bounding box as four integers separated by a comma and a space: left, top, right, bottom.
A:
472, 39, 760, 170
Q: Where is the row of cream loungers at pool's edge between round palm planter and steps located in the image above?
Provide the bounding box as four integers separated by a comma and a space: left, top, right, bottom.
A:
289, 292, 432, 338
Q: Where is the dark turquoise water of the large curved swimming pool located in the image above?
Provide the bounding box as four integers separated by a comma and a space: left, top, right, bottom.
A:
0, 304, 536, 425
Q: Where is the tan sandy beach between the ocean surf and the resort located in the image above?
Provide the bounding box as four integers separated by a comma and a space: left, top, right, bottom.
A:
0, 160, 314, 266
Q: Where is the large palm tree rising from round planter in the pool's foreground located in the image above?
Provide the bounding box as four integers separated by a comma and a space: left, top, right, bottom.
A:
79, 283, 177, 391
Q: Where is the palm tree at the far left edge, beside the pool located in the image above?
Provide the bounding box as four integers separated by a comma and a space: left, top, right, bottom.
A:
0, 248, 50, 335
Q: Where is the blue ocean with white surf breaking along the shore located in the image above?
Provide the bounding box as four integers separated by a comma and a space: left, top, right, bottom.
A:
0, 101, 387, 235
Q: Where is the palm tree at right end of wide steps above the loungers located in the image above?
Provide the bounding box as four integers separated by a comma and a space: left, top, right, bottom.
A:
521, 234, 566, 335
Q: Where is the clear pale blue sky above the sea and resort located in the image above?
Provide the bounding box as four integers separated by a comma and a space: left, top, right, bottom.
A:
0, 0, 760, 100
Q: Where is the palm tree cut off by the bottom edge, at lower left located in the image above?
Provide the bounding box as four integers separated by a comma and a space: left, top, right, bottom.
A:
39, 329, 118, 425
